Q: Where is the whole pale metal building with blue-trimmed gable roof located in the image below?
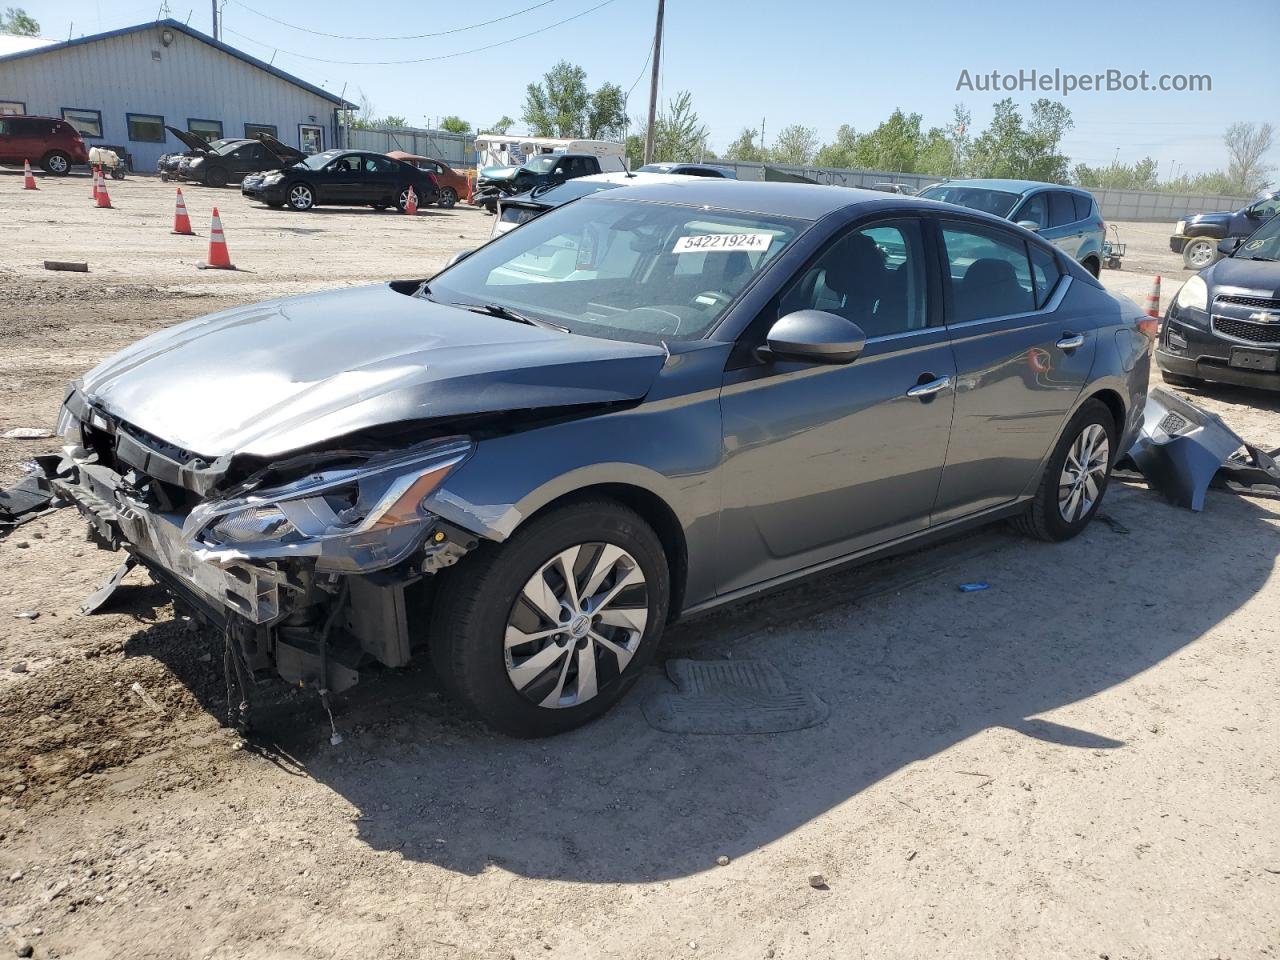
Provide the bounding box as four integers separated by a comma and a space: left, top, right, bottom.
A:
0, 19, 351, 172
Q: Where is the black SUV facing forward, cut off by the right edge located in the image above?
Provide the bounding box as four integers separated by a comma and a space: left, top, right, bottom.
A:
1156, 216, 1280, 390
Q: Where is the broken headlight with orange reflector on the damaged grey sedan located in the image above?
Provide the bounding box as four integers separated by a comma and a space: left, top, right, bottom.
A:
183, 439, 472, 573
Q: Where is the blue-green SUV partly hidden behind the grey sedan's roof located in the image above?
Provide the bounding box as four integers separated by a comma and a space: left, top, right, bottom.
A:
919, 180, 1106, 276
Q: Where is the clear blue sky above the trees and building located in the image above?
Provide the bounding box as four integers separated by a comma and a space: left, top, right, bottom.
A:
24, 0, 1280, 177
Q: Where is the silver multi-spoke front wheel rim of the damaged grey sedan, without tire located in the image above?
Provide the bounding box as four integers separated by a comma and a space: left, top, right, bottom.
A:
503, 543, 649, 709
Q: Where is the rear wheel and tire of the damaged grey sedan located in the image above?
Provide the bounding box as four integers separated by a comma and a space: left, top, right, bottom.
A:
1014, 399, 1117, 541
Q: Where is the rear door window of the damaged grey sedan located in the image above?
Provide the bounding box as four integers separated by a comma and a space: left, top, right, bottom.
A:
942, 221, 1036, 324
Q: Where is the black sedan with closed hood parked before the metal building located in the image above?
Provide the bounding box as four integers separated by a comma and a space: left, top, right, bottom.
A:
241, 147, 439, 210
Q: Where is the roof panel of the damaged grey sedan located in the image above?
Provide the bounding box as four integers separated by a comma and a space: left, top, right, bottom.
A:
586, 174, 937, 220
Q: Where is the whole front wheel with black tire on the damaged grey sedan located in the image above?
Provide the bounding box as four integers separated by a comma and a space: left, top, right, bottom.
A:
430, 500, 671, 737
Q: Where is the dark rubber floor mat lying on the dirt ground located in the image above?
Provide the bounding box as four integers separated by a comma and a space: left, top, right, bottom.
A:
643, 659, 828, 735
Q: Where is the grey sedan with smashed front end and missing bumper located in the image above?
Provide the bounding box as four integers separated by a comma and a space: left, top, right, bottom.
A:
54, 181, 1151, 736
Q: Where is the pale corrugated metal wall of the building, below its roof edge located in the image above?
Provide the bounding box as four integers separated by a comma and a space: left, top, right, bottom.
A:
0, 24, 337, 170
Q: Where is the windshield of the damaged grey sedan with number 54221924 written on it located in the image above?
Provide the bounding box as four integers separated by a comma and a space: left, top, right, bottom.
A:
425, 197, 808, 344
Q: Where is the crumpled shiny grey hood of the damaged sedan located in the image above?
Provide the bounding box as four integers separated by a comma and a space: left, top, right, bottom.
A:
82, 284, 666, 458
